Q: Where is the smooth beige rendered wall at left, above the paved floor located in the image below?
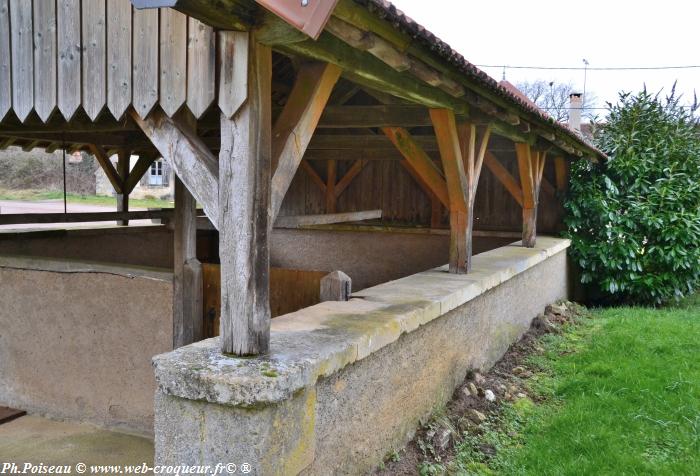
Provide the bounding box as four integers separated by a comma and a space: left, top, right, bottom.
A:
0, 257, 172, 434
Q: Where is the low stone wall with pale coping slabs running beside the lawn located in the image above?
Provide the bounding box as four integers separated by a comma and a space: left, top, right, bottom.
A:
154, 238, 568, 475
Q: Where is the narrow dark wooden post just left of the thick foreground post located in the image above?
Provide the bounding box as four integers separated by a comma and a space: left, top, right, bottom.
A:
173, 176, 204, 349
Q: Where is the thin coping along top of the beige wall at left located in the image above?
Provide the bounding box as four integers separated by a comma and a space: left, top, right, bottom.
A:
0, 255, 173, 282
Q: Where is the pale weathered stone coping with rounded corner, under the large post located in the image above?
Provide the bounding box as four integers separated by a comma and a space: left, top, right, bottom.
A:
153, 237, 570, 407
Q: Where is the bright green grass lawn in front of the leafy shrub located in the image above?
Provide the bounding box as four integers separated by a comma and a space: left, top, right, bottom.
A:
474, 296, 700, 475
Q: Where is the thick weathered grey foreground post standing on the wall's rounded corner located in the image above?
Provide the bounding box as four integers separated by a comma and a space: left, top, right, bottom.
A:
219, 32, 272, 355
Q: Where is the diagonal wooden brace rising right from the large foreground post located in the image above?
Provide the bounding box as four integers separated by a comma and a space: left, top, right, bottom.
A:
271, 63, 341, 219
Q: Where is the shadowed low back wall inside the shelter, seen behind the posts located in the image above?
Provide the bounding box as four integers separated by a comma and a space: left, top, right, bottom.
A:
0, 226, 513, 291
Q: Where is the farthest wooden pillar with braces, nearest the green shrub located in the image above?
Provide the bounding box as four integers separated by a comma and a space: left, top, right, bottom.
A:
515, 142, 546, 248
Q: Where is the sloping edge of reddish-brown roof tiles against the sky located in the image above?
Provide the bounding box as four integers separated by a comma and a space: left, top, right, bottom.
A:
354, 0, 607, 158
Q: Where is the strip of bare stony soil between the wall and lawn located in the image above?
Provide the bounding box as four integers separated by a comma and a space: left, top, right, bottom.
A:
372, 301, 584, 475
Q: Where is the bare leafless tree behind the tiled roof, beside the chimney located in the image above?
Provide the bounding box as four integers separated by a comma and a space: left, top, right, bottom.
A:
516, 79, 596, 122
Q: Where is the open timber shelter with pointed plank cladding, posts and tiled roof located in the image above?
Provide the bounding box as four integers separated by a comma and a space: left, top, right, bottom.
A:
0, 0, 604, 355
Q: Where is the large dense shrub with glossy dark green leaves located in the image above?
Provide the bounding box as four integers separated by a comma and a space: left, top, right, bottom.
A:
565, 90, 700, 305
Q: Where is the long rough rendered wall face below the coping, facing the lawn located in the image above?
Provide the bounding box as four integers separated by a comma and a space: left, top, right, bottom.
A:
304, 252, 567, 475
